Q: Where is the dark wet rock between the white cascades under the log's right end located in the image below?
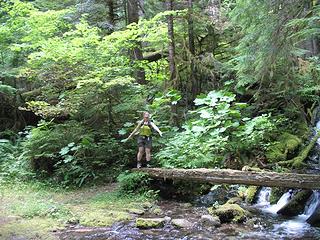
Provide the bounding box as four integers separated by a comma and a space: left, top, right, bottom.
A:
277, 190, 312, 217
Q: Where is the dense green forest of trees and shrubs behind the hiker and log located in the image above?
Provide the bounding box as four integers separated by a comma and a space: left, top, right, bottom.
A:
0, 0, 320, 186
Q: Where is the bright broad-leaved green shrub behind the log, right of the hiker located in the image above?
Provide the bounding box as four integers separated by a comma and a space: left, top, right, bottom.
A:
157, 91, 276, 168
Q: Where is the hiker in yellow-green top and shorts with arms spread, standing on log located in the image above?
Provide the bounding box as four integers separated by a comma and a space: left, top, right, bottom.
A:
124, 112, 162, 168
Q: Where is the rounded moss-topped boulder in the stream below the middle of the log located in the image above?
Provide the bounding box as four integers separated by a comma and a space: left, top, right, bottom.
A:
208, 203, 249, 223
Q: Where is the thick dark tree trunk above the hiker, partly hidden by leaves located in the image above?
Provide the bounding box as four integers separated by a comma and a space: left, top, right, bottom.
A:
127, 0, 147, 84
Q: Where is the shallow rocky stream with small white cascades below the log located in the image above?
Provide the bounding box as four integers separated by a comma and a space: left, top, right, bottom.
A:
60, 188, 320, 240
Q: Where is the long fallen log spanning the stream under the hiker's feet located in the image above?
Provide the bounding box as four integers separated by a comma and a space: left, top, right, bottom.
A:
133, 168, 320, 189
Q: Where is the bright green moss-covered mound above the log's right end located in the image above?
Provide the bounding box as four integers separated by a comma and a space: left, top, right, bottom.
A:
266, 132, 302, 162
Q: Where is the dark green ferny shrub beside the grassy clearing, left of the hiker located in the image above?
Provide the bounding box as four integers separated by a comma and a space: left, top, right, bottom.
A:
23, 121, 130, 186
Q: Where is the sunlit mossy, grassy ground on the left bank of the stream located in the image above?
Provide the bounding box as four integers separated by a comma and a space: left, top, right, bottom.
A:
0, 182, 153, 240
